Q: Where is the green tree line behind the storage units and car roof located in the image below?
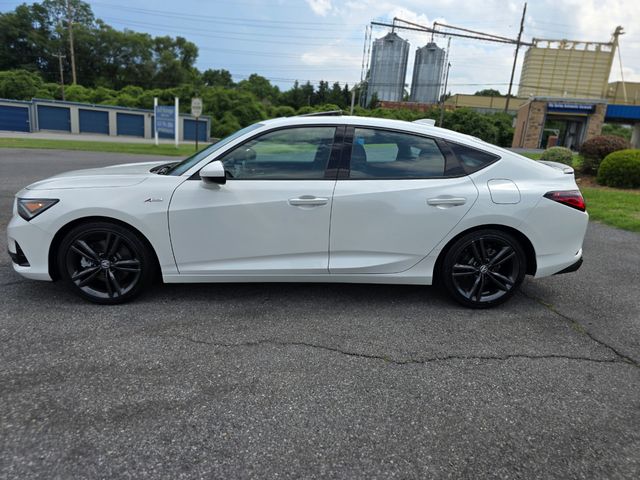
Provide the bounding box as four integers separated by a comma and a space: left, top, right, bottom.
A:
0, 0, 512, 145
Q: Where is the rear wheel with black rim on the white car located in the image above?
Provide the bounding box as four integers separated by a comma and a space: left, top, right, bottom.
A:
440, 229, 526, 308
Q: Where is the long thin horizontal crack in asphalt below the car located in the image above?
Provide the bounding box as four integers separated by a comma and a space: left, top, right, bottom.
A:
163, 335, 629, 365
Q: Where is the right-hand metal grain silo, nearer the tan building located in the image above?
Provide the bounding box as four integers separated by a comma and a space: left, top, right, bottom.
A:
409, 42, 445, 103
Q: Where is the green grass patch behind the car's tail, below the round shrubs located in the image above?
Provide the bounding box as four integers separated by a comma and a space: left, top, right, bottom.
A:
580, 187, 640, 232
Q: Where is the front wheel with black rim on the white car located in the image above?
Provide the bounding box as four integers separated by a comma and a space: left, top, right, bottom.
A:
57, 222, 155, 305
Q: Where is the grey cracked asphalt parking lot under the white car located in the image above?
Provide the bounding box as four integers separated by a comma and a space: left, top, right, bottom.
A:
0, 149, 640, 479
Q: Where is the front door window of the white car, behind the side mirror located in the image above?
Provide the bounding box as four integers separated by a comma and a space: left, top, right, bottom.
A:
220, 127, 336, 180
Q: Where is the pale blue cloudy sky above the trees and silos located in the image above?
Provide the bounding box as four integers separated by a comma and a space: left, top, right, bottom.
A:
0, 0, 640, 93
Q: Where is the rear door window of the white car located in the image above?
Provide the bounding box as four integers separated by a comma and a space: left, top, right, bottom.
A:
349, 128, 446, 179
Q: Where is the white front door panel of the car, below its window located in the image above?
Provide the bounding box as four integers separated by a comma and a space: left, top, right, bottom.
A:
169, 180, 335, 275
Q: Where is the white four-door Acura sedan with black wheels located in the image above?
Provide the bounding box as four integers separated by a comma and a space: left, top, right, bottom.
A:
8, 115, 588, 307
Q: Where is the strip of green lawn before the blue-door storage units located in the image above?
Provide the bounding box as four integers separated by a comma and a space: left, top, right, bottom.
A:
0, 138, 208, 157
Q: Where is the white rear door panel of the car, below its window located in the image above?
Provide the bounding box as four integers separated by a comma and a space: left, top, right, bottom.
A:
329, 177, 478, 274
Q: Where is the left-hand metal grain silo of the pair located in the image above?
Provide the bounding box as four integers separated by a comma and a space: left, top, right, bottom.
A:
367, 32, 409, 105
